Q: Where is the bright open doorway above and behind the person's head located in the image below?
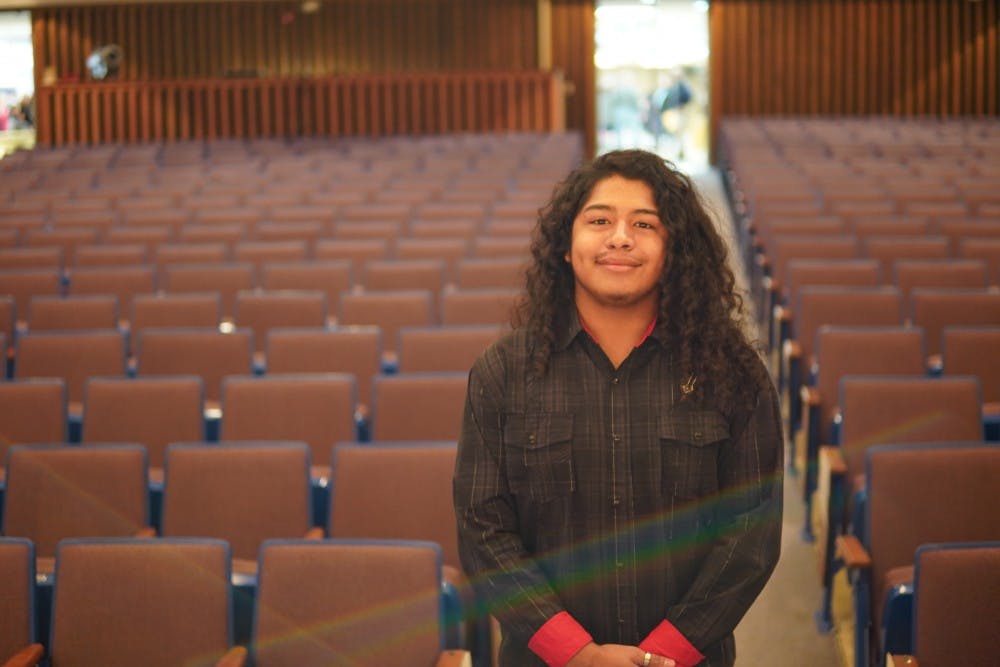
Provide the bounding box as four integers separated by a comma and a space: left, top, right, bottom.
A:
594, 0, 709, 170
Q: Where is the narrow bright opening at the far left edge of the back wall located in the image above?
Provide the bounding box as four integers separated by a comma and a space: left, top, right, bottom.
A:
0, 11, 35, 157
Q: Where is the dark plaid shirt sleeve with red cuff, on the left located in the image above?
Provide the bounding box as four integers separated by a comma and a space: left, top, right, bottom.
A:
453, 348, 589, 667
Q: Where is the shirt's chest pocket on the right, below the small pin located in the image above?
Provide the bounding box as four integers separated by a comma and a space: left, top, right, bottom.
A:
660, 410, 729, 498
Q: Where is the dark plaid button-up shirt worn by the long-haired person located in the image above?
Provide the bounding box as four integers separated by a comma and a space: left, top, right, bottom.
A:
454, 320, 783, 667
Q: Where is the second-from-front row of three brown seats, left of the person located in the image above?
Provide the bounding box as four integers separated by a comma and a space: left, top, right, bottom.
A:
2, 441, 471, 646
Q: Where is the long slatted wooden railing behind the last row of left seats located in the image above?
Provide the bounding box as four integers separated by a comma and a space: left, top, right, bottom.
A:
35, 71, 566, 146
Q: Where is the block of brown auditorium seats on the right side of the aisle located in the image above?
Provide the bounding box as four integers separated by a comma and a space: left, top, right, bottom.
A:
720, 118, 1000, 667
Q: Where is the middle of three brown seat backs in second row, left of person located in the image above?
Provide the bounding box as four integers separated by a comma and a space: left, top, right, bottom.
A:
162, 442, 311, 560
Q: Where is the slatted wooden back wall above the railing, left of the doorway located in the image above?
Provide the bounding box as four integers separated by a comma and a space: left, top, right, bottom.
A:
33, 0, 538, 85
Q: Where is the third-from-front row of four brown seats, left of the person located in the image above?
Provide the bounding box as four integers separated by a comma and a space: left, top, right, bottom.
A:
0, 372, 467, 472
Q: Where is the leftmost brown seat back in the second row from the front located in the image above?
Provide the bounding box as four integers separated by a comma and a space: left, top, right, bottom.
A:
3, 445, 149, 557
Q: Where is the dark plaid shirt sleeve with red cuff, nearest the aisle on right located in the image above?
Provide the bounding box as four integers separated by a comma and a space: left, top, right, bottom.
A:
640, 376, 784, 667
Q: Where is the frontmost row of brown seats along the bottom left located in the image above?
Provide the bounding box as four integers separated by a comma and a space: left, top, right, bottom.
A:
0, 538, 471, 667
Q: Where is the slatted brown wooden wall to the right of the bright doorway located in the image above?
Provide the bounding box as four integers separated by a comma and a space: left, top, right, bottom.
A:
709, 0, 1000, 159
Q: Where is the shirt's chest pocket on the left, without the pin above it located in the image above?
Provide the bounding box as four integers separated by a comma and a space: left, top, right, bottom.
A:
503, 413, 575, 502
